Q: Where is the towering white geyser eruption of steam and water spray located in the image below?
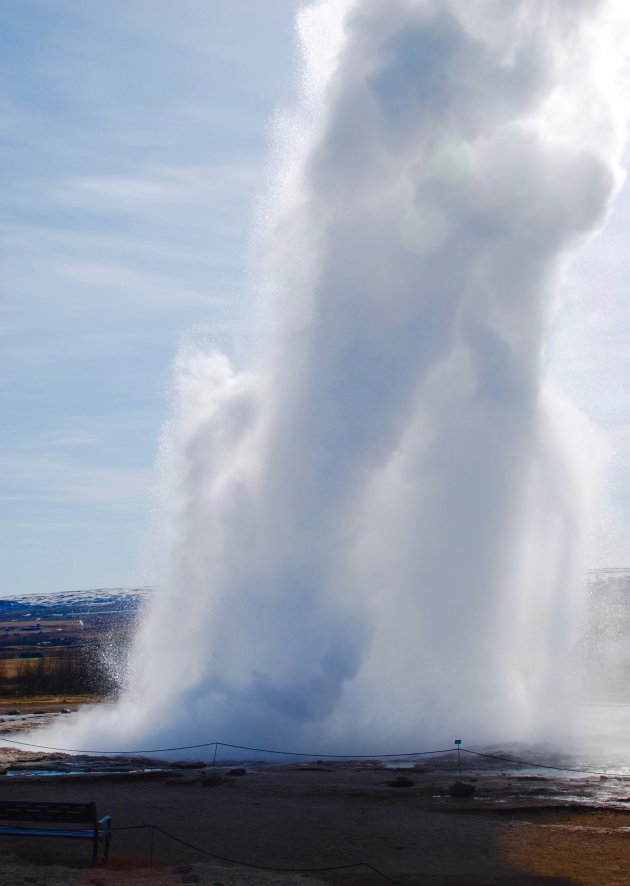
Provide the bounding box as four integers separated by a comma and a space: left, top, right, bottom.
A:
56, 0, 624, 753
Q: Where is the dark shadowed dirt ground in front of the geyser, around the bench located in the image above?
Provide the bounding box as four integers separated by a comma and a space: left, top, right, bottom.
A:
0, 752, 630, 886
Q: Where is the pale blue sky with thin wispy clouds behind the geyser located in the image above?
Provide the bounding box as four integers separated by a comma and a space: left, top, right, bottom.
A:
0, 0, 630, 596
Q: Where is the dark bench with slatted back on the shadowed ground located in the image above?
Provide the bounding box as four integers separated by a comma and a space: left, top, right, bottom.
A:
0, 800, 112, 865
